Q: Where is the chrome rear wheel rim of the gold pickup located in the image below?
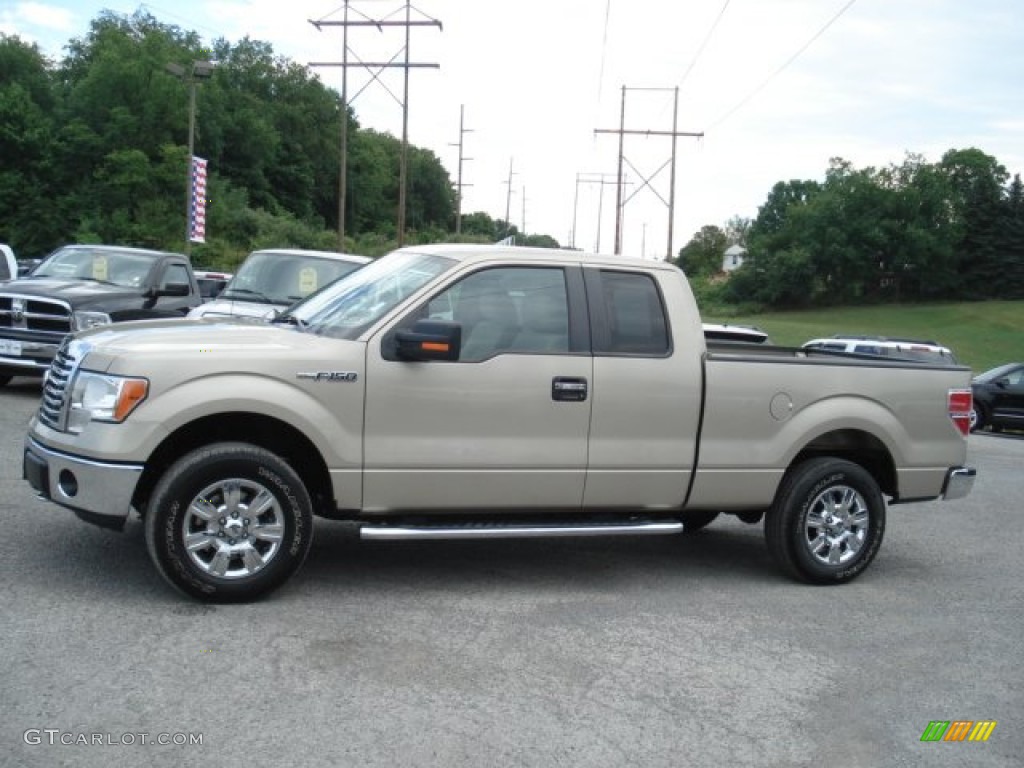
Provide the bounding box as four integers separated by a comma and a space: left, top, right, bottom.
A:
804, 485, 870, 565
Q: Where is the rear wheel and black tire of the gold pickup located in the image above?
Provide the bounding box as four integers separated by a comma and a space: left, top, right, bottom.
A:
765, 458, 886, 584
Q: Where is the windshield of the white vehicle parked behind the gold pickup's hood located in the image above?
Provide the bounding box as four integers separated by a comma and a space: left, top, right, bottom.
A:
220, 251, 361, 306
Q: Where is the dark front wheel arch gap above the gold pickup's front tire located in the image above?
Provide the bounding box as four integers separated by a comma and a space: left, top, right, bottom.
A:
132, 412, 335, 514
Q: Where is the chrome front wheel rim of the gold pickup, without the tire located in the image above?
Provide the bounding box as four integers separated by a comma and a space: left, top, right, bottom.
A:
181, 478, 285, 579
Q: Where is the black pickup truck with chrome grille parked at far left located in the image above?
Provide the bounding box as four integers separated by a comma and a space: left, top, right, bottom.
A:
0, 246, 203, 386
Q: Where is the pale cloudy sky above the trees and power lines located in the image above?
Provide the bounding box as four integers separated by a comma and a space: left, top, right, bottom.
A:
0, 0, 1024, 258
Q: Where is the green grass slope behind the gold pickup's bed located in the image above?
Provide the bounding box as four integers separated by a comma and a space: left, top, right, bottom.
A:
705, 301, 1024, 373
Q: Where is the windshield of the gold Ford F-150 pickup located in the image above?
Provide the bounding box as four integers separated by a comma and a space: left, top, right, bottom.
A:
285, 251, 456, 339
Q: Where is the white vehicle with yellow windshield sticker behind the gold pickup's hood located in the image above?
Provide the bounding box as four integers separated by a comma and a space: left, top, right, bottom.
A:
188, 248, 370, 319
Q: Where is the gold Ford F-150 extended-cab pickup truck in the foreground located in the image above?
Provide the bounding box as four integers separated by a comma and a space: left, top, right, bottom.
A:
24, 246, 975, 601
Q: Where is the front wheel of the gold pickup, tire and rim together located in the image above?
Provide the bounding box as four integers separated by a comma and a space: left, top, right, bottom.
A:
145, 442, 312, 602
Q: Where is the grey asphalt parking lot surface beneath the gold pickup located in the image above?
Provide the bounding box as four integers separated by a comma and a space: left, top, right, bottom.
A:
0, 379, 1024, 768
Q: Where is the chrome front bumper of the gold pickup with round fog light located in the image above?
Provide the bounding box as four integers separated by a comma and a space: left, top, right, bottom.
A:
22, 436, 142, 530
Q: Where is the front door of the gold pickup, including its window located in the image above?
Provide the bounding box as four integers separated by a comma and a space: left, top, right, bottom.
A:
364, 267, 593, 512
